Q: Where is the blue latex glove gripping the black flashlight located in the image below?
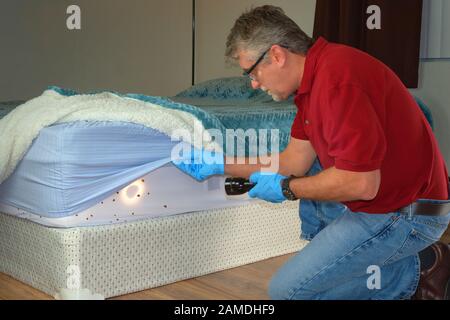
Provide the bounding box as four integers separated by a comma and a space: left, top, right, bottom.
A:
248, 172, 286, 203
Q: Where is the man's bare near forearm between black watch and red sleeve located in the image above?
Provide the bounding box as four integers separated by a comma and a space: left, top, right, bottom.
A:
289, 167, 379, 201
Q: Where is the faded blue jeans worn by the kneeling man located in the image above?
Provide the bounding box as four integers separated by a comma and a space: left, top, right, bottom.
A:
269, 160, 450, 300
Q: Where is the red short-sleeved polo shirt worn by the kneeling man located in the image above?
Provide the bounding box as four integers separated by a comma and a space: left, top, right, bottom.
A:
291, 38, 448, 213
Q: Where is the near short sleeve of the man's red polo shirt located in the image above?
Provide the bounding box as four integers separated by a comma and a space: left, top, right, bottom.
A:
322, 85, 387, 172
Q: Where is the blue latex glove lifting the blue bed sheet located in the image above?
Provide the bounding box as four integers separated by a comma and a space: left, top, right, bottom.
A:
172, 148, 225, 181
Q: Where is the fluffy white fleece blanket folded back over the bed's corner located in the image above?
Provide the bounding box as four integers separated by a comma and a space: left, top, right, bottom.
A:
0, 90, 217, 183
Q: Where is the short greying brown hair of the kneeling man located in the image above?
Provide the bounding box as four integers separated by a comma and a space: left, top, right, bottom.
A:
225, 5, 313, 62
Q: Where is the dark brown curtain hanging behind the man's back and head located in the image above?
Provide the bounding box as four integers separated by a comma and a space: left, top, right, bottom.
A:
313, 0, 422, 88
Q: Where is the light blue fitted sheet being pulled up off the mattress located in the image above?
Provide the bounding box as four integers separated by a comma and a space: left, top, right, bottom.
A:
0, 121, 174, 218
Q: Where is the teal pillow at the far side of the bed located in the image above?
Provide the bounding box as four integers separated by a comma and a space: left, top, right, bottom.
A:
175, 77, 265, 100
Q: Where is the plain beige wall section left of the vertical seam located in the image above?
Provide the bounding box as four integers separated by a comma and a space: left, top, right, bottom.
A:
0, 0, 192, 101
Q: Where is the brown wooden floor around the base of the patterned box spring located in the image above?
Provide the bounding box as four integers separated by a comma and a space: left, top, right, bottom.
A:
0, 228, 450, 300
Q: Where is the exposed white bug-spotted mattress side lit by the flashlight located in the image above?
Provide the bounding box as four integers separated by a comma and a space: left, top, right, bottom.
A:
0, 164, 261, 228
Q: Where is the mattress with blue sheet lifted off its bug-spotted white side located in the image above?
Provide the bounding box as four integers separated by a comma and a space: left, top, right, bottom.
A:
0, 122, 256, 227
